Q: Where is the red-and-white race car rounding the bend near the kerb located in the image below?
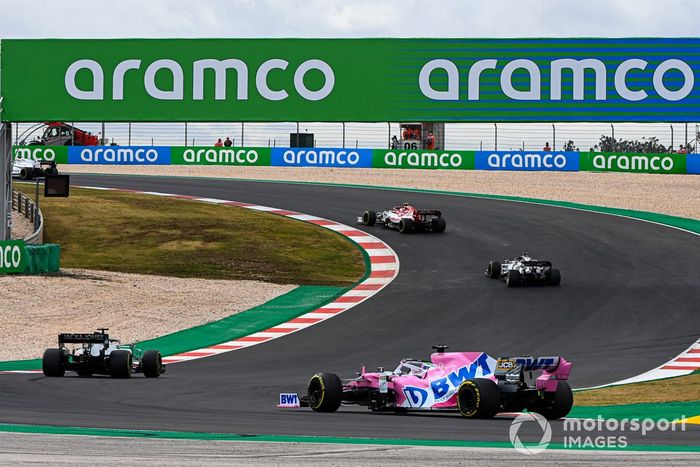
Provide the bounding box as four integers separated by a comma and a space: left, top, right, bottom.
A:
357, 203, 447, 233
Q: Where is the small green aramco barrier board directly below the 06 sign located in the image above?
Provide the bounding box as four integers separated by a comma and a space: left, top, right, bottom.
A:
372, 149, 474, 170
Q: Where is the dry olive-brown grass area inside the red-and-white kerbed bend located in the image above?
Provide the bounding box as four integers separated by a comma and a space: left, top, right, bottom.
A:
15, 184, 364, 286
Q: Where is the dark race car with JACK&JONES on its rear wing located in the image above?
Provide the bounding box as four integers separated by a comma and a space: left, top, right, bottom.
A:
42, 328, 165, 378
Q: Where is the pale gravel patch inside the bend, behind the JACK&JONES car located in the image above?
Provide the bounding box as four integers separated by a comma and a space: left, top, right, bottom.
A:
0, 269, 294, 361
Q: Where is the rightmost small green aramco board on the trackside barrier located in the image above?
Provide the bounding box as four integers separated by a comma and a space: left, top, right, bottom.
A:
579, 152, 687, 174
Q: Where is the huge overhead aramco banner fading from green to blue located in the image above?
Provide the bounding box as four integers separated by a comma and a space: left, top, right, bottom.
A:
0, 38, 700, 122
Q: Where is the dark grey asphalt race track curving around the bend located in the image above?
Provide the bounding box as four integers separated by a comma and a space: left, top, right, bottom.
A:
0, 175, 700, 444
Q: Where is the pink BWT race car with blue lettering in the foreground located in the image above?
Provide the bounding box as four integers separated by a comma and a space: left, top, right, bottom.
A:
300, 346, 574, 419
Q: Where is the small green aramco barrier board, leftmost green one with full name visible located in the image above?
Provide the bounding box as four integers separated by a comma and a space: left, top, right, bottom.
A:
170, 146, 270, 166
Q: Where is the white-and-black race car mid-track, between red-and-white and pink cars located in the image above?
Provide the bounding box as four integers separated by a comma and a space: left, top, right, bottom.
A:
484, 253, 561, 287
